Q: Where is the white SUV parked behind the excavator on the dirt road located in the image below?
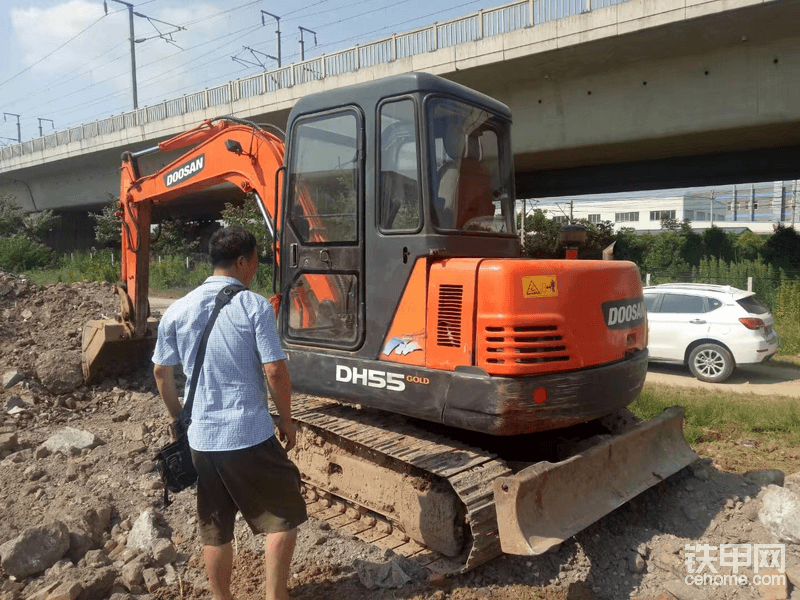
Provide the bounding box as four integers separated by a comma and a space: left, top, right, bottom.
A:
644, 283, 778, 383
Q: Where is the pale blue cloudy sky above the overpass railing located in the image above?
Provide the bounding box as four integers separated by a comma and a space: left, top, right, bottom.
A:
0, 0, 488, 145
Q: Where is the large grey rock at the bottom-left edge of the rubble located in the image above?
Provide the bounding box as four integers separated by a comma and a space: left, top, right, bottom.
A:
0, 521, 69, 578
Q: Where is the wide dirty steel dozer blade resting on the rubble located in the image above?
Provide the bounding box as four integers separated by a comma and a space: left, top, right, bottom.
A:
494, 406, 697, 555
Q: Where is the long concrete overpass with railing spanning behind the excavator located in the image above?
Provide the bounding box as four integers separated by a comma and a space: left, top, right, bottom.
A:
0, 0, 800, 243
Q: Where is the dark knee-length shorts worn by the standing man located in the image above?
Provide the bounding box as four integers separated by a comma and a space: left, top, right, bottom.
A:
192, 436, 308, 546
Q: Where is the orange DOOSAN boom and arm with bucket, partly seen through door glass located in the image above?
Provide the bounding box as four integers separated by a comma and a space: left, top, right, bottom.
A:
82, 118, 339, 381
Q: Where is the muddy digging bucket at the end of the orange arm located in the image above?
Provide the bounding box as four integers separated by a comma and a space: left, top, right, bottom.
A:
81, 319, 158, 382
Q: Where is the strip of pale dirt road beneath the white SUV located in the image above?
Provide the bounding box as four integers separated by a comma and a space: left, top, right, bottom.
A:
647, 363, 800, 398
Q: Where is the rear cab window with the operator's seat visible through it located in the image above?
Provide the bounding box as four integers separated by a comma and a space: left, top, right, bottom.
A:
427, 97, 514, 234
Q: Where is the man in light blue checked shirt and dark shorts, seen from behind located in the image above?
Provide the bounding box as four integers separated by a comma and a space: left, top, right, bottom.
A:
153, 227, 307, 600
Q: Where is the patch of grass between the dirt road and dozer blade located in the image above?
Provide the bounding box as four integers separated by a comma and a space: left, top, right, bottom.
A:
628, 384, 800, 473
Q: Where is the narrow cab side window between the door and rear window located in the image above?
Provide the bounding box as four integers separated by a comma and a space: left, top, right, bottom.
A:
378, 99, 422, 232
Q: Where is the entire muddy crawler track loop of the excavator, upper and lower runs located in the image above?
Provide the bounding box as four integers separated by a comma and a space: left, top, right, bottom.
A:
282, 395, 512, 574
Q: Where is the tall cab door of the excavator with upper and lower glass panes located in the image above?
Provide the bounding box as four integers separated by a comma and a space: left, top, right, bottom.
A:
281, 107, 364, 350
